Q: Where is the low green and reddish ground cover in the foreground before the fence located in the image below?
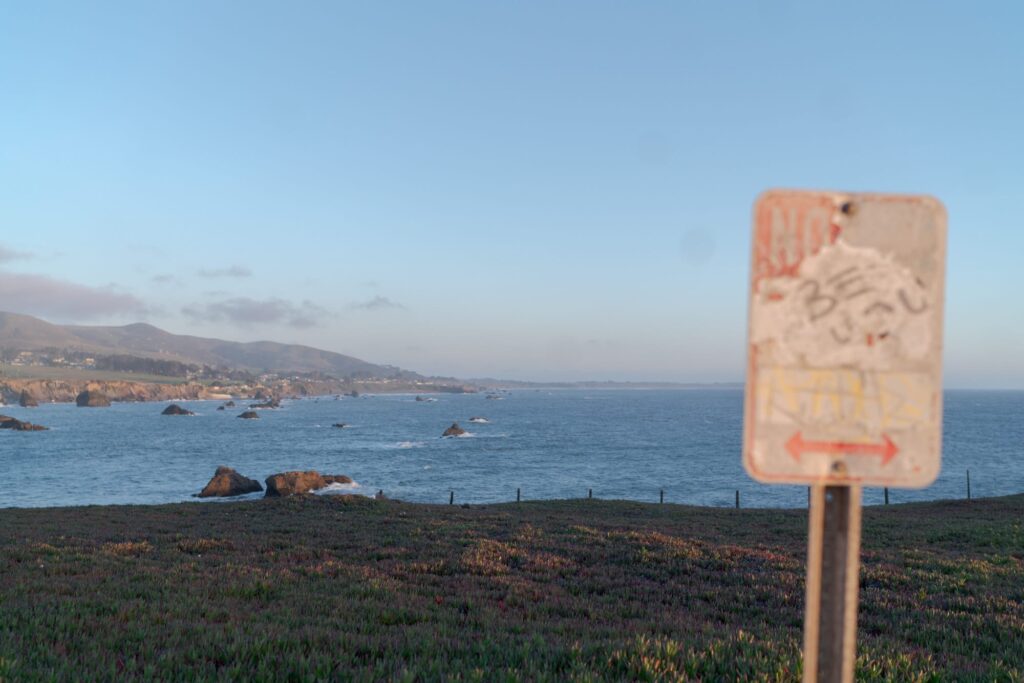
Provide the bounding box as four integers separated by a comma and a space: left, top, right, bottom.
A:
0, 496, 1024, 681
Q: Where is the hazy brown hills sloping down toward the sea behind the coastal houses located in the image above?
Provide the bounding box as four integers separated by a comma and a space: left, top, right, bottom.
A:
0, 312, 411, 379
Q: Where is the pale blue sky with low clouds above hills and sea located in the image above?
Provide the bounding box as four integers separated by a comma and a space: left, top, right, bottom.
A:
0, 0, 1024, 388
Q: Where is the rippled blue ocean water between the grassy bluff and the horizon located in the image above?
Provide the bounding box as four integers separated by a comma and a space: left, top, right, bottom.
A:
0, 388, 1024, 508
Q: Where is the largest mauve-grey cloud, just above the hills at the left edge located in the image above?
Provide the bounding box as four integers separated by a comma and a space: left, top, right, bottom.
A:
0, 272, 146, 321
